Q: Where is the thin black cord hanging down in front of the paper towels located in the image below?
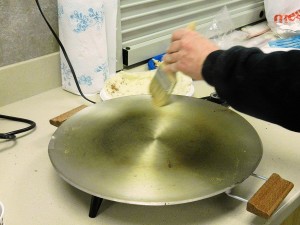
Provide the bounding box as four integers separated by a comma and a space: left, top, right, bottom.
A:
35, 0, 96, 104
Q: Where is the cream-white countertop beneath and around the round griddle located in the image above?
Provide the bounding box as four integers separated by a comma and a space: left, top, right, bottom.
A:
0, 79, 300, 225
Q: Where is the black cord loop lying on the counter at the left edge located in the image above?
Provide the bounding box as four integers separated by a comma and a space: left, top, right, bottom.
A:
0, 114, 36, 140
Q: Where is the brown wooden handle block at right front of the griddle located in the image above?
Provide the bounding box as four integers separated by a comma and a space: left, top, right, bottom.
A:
247, 173, 294, 219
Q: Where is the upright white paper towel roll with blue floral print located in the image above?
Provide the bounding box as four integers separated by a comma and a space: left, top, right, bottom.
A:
58, 0, 109, 95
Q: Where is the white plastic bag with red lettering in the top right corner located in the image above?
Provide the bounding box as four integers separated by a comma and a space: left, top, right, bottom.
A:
264, 0, 300, 38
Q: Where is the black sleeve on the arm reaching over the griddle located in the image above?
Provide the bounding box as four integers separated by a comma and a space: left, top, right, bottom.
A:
202, 46, 300, 132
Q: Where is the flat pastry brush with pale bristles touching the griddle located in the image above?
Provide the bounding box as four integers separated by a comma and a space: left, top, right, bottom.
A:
149, 22, 196, 107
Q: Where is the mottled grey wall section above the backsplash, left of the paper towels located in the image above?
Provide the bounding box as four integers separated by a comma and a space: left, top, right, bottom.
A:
0, 0, 58, 67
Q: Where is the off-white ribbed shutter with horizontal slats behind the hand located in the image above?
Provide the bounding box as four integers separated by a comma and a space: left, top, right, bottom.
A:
120, 0, 264, 66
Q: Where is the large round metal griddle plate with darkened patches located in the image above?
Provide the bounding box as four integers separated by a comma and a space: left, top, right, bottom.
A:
49, 95, 262, 205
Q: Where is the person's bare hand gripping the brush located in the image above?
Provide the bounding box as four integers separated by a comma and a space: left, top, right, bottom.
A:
163, 29, 219, 80
